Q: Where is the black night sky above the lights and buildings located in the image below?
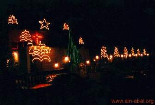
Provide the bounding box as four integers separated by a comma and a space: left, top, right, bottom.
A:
0, 0, 155, 53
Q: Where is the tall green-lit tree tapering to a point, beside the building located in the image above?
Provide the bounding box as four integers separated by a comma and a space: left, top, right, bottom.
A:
67, 30, 81, 72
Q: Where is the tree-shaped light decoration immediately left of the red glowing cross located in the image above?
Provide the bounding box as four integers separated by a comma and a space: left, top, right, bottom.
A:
20, 30, 32, 42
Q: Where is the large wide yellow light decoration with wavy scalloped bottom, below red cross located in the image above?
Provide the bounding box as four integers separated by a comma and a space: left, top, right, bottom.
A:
29, 44, 51, 62
